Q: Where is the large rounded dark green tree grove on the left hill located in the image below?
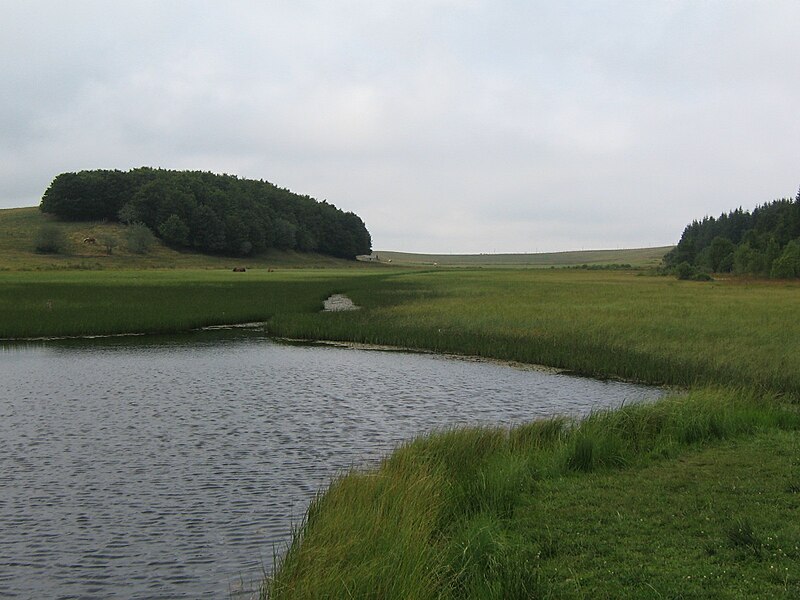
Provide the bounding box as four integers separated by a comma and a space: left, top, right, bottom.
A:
40, 167, 372, 258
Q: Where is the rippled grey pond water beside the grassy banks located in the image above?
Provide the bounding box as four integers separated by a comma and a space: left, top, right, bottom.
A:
0, 330, 662, 599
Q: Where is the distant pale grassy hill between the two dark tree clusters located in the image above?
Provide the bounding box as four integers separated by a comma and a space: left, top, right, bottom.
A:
362, 246, 674, 268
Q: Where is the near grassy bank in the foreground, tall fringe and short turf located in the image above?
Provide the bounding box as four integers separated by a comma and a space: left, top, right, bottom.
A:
269, 390, 800, 599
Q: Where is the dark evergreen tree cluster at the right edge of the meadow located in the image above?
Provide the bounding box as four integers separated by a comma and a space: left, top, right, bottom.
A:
665, 192, 800, 278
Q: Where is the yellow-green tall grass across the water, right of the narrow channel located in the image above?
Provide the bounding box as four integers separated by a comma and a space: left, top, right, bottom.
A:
272, 271, 800, 395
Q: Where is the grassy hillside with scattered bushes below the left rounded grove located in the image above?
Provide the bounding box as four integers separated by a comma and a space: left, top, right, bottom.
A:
0, 207, 372, 271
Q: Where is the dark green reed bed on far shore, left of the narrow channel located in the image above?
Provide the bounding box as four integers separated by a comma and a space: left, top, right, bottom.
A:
0, 270, 384, 338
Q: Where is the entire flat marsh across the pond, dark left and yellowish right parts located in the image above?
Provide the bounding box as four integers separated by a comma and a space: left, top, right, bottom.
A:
7, 269, 800, 397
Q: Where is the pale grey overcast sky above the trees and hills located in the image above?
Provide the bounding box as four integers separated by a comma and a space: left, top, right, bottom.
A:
0, 0, 800, 253
